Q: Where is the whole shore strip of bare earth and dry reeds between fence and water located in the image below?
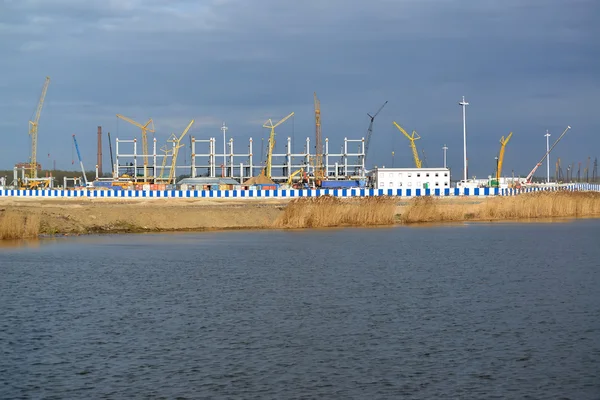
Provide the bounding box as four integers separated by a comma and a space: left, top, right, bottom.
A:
0, 191, 600, 239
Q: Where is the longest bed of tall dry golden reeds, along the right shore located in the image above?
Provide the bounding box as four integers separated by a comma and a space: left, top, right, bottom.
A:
401, 191, 600, 223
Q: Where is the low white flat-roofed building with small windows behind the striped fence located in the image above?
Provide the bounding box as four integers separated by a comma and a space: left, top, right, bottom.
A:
371, 168, 450, 189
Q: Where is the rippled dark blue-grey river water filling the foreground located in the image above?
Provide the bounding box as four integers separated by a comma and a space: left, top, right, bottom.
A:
0, 220, 600, 399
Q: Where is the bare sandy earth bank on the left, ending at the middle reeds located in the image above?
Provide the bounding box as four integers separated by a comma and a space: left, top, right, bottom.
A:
0, 198, 285, 239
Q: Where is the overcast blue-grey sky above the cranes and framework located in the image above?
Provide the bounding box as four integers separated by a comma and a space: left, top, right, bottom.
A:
0, 0, 600, 178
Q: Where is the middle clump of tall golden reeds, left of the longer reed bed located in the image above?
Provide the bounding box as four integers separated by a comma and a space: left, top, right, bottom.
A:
273, 196, 397, 228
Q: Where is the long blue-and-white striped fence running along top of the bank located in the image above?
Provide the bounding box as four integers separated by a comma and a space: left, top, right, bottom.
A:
0, 183, 600, 199
